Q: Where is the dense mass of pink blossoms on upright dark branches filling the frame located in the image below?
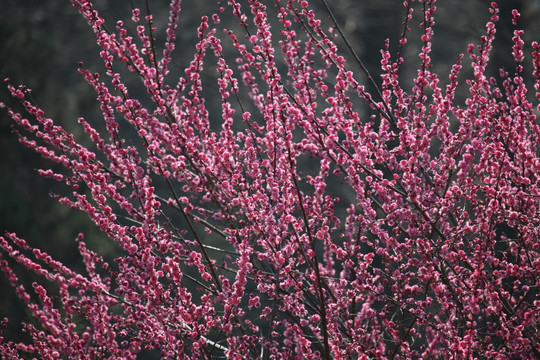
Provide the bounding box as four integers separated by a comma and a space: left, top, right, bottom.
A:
0, 0, 540, 359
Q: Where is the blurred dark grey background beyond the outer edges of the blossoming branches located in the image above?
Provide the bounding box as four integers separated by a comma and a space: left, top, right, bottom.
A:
0, 0, 540, 348
